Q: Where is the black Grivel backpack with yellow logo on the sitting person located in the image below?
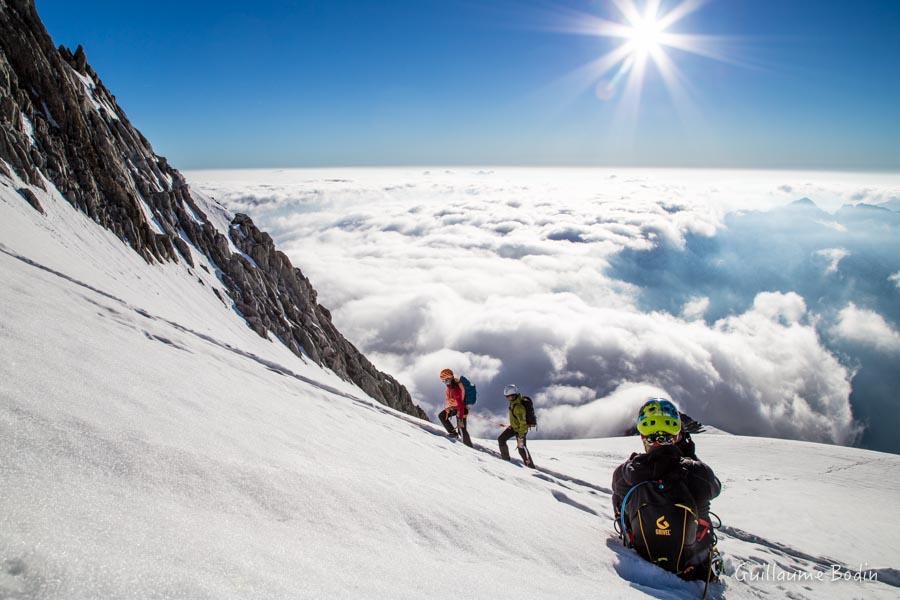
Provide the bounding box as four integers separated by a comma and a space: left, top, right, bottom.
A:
620, 479, 700, 575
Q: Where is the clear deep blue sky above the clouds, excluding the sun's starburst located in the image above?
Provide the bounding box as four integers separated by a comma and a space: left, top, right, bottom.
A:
37, 0, 900, 171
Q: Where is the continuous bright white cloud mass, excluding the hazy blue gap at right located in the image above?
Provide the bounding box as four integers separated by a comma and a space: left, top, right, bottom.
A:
189, 169, 872, 442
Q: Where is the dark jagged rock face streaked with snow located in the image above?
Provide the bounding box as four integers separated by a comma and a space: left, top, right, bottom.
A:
0, 0, 425, 418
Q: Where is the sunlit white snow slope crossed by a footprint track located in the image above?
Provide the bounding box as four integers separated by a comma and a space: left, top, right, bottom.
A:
0, 180, 900, 599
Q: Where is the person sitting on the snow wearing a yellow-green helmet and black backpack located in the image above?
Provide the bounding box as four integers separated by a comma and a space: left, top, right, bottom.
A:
612, 398, 722, 581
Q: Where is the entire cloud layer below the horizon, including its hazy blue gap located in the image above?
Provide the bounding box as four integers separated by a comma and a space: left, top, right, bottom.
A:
187, 168, 900, 451
